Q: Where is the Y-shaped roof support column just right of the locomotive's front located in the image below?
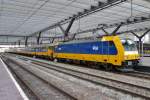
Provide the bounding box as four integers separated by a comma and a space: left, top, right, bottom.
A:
131, 29, 150, 57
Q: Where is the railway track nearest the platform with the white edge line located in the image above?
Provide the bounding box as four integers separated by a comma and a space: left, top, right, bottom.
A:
0, 57, 76, 100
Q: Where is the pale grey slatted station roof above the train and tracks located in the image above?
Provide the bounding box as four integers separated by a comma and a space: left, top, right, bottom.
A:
0, 0, 150, 43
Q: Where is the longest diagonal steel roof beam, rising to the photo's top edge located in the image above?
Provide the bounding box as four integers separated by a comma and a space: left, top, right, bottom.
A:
30, 0, 127, 36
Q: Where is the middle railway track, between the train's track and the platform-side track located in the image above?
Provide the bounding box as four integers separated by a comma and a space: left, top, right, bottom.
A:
7, 54, 150, 99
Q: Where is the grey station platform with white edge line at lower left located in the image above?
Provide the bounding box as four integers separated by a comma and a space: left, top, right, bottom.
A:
0, 59, 28, 100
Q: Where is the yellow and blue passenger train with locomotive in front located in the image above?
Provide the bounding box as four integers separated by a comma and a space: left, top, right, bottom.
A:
8, 36, 139, 70
